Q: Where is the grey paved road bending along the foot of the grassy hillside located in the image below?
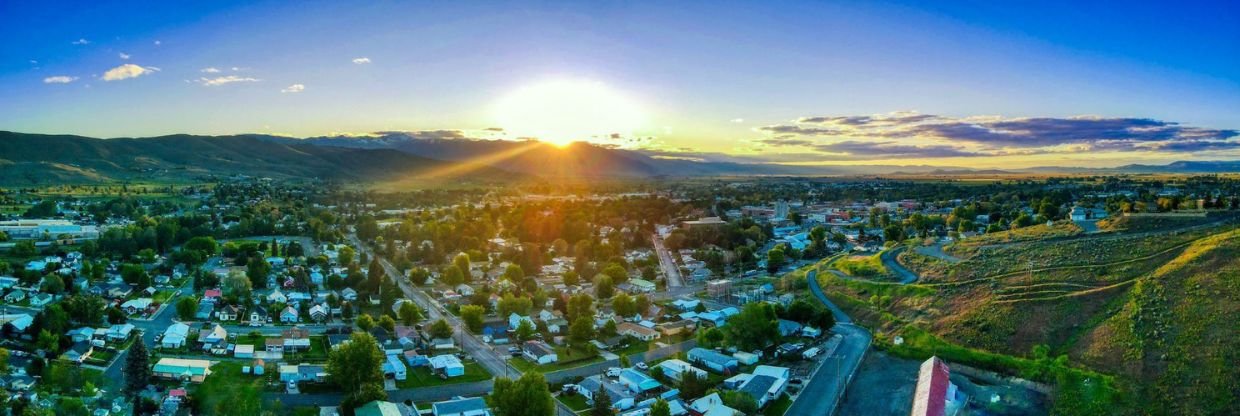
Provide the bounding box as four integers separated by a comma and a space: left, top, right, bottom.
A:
787, 272, 872, 415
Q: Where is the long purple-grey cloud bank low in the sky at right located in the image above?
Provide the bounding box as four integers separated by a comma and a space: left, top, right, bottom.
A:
755, 112, 1240, 158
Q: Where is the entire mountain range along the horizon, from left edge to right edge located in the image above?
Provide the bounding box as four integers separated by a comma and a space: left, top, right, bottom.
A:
0, 132, 1240, 185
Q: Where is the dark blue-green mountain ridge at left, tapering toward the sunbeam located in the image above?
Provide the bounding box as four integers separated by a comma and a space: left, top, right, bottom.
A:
0, 132, 511, 185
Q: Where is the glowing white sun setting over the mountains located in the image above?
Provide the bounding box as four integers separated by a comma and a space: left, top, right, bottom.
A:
495, 79, 645, 147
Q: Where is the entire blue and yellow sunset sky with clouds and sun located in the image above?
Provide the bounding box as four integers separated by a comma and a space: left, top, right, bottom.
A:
0, 1, 1240, 168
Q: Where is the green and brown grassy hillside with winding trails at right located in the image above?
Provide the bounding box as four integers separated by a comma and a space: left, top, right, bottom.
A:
820, 221, 1240, 415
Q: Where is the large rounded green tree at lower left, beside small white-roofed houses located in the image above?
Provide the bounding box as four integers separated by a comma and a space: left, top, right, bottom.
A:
326, 332, 384, 396
